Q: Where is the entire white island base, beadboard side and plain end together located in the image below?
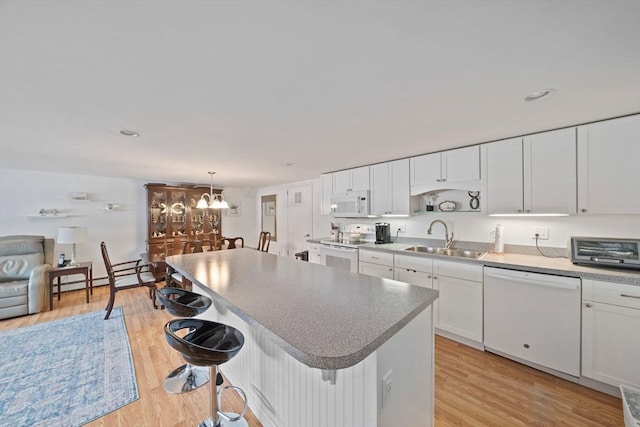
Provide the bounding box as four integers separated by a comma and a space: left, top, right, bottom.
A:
194, 284, 434, 427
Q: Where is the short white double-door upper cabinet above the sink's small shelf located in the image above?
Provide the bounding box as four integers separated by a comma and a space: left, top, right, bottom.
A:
410, 146, 480, 195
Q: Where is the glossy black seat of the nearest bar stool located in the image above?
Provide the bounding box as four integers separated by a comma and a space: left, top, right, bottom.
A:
164, 319, 244, 366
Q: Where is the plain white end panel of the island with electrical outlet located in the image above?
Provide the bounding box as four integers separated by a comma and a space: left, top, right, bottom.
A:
376, 306, 435, 427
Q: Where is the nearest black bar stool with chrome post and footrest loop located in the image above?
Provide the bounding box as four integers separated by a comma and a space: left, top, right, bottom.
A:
164, 319, 248, 427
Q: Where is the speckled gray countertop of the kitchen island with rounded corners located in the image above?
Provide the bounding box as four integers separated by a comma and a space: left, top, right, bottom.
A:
166, 248, 438, 369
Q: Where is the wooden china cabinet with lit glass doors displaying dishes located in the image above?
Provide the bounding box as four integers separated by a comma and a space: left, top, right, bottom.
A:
145, 184, 222, 280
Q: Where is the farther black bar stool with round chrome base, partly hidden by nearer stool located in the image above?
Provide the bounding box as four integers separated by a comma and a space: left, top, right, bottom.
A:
156, 287, 211, 393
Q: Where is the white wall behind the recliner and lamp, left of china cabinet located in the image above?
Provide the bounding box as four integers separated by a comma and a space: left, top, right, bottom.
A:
0, 169, 146, 277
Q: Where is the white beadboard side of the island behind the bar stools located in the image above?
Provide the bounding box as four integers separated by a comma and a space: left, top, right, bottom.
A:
193, 283, 378, 427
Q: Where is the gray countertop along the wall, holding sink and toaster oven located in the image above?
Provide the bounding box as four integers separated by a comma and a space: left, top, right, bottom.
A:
358, 243, 640, 286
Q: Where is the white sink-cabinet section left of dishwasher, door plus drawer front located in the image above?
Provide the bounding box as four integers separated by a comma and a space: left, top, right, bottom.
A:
433, 260, 483, 344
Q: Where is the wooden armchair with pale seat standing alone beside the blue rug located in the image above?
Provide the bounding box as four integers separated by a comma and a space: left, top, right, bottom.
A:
100, 242, 158, 320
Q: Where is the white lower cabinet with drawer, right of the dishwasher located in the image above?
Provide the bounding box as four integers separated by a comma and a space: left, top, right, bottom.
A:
582, 280, 640, 387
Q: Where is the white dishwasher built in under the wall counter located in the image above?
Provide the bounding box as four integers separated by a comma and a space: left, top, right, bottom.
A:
484, 267, 581, 377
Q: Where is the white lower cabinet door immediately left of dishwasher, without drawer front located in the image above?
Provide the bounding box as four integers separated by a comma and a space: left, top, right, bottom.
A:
433, 276, 482, 342
